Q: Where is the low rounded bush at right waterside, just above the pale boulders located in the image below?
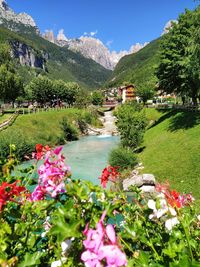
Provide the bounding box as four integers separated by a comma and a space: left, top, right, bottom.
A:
108, 147, 137, 171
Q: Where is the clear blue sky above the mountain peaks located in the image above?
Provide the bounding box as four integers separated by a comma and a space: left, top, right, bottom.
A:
7, 0, 197, 51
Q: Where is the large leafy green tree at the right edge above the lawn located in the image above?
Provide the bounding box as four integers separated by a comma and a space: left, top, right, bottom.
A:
157, 7, 200, 104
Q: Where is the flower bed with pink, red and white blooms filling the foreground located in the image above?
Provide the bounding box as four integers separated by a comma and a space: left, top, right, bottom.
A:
0, 144, 200, 267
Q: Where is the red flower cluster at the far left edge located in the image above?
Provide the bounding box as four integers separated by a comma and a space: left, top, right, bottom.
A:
0, 181, 26, 211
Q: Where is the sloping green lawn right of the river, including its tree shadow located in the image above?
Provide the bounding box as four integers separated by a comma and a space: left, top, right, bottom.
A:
139, 109, 200, 204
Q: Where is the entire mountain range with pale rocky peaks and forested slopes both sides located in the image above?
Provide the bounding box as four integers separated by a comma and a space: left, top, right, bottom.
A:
0, 0, 163, 90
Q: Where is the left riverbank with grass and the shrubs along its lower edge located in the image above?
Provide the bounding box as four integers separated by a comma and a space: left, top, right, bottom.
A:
0, 108, 101, 160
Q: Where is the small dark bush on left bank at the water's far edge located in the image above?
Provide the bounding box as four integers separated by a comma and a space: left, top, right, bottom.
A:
60, 117, 78, 141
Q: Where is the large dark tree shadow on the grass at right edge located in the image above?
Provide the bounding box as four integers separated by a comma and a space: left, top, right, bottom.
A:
168, 111, 200, 132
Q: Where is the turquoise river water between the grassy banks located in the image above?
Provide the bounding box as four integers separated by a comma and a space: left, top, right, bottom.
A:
63, 135, 119, 184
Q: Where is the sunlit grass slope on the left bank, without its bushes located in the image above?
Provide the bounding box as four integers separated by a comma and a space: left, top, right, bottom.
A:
1, 108, 100, 148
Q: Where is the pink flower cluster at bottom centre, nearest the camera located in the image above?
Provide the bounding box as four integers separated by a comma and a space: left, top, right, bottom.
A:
81, 212, 127, 267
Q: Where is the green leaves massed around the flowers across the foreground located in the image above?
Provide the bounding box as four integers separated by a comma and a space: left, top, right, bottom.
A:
0, 150, 200, 267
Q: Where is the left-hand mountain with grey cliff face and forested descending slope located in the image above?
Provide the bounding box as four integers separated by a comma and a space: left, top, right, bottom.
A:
0, 0, 111, 90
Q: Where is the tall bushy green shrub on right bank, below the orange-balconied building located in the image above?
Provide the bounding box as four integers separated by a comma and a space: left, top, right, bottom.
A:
116, 102, 147, 149
